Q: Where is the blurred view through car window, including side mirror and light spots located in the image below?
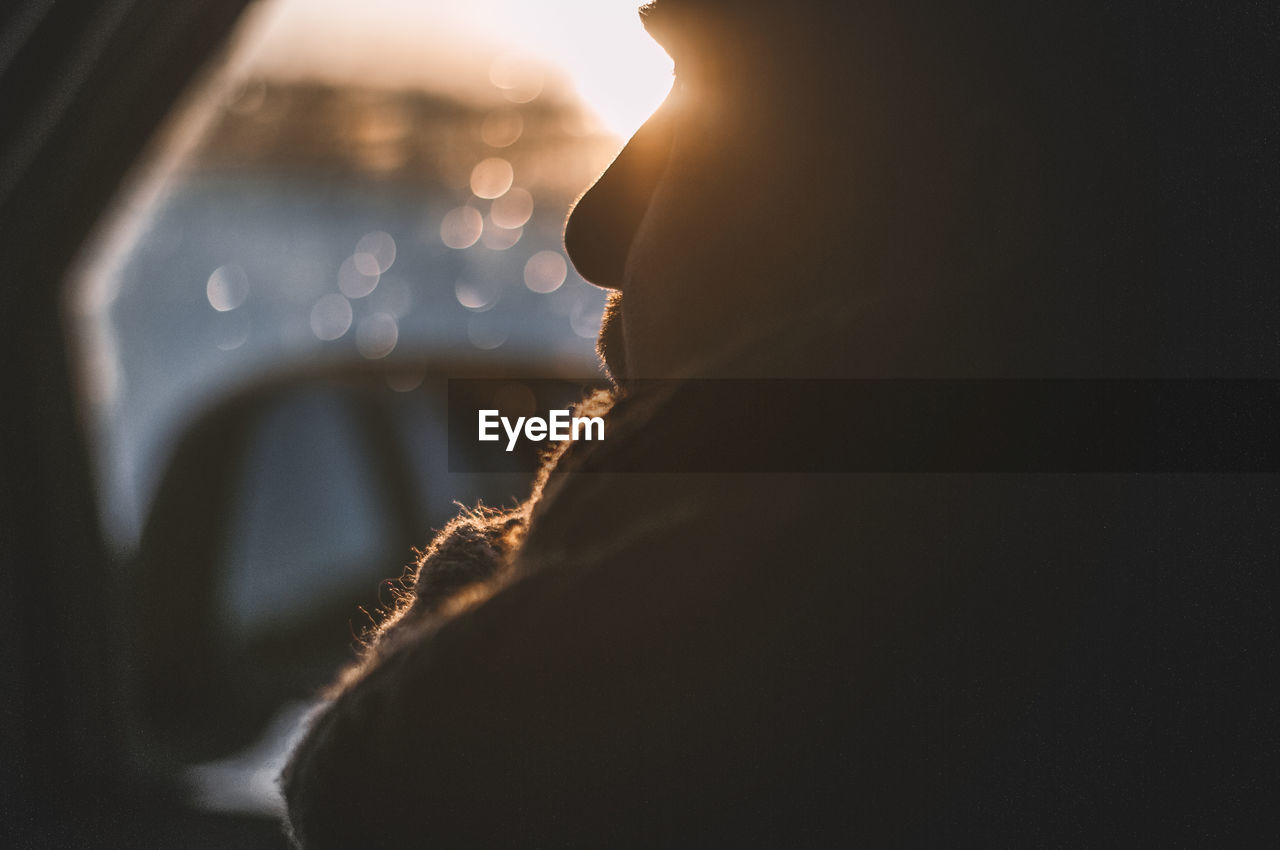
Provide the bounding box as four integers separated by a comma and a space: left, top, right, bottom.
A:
64, 0, 671, 817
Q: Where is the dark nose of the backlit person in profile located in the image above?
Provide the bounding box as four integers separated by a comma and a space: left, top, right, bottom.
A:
564, 99, 672, 289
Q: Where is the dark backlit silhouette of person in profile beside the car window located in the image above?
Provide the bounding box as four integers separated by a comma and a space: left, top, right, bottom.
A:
284, 0, 1280, 847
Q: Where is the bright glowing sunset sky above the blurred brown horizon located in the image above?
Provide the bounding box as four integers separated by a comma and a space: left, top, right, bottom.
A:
231, 0, 671, 137
